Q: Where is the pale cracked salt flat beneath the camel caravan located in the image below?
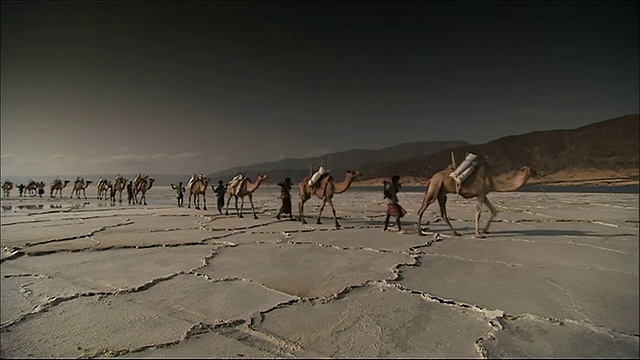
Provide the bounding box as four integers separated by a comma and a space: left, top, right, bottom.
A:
0, 185, 640, 358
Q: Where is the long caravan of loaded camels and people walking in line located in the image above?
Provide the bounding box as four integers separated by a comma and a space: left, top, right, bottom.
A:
2, 152, 536, 238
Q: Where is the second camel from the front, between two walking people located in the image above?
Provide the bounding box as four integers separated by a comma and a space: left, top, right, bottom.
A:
298, 170, 362, 228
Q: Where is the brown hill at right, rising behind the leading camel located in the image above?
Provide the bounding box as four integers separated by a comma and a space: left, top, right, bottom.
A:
359, 114, 640, 186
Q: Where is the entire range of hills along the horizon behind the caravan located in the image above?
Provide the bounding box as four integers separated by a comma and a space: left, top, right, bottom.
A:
11, 114, 640, 186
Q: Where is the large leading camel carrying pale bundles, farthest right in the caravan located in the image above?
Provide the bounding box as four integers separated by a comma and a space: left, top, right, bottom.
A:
418, 155, 536, 238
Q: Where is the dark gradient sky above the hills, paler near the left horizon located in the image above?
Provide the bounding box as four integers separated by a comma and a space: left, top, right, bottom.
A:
1, 1, 640, 178
